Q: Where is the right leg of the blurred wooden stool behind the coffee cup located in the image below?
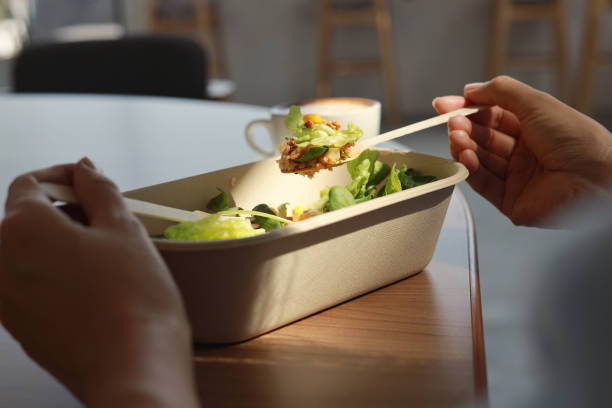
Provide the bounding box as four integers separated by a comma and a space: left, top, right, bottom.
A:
374, 0, 400, 123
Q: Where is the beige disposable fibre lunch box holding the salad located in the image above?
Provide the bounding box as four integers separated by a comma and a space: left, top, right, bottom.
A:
125, 149, 468, 343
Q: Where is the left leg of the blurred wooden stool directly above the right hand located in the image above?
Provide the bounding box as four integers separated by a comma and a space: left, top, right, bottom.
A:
489, 0, 512, 78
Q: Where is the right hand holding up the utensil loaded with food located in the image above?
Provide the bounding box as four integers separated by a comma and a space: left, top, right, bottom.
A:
434, 77, 612, 225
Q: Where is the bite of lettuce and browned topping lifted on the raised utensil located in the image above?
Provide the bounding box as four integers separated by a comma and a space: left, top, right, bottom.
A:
278, 105, 363, 178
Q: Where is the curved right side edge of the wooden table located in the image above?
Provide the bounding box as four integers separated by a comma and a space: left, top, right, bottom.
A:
456, 189, 489, 406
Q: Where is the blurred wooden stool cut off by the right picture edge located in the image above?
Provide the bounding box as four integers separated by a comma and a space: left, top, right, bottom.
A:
576, 0, 612, 114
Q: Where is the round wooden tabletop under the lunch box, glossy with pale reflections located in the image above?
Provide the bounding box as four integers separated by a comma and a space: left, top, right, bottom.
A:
0, 95, 487, 407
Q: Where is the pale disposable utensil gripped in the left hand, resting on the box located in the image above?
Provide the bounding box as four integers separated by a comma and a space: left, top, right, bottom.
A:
40, 183, 209, 222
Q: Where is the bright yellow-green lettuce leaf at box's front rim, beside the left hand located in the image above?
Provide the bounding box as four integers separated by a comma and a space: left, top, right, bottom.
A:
164, 215, 265, 241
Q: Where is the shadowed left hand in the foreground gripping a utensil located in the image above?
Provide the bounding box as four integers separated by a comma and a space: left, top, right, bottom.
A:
0, 159, 197, 407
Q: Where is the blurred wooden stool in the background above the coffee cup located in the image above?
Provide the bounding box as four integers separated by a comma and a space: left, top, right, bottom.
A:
317, 0, 400, 123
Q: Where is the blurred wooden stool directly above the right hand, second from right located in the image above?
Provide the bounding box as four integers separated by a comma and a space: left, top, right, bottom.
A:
489, 0, 567, 100
